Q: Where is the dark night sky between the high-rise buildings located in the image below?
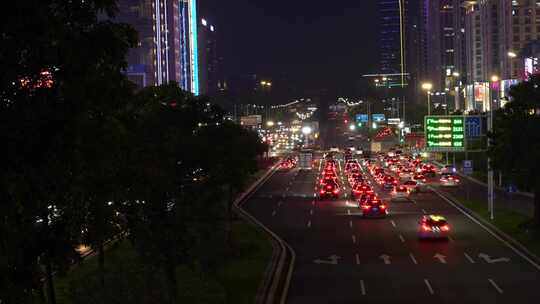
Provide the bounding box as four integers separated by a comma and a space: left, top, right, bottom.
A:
199, 0, 378, 97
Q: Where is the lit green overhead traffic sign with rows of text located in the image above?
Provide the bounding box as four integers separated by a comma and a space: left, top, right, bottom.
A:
424, 115, 466, 152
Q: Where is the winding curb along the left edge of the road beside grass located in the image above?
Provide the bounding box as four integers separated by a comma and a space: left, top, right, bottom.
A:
233, 164, 296, 304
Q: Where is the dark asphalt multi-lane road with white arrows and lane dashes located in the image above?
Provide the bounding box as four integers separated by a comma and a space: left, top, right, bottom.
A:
244, 155, 540, 304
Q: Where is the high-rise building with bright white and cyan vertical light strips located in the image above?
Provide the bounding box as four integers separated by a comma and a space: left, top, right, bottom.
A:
116, 0, 199, 95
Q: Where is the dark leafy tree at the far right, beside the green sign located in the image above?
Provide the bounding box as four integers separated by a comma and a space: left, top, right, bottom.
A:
488, 75, 540, 227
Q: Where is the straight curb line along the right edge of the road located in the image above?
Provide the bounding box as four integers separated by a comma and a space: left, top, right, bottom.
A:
429, 186, 540, 271
